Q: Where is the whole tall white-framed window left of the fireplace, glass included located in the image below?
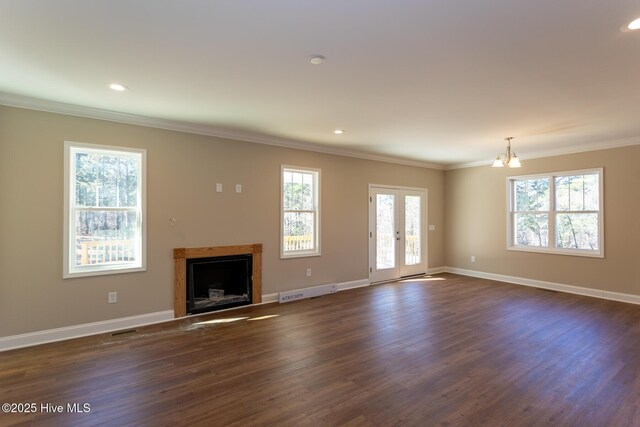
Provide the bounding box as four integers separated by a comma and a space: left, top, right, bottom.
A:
63, 142, 146, 278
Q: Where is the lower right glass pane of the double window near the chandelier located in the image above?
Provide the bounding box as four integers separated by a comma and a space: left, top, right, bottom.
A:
556, 213, 598, 251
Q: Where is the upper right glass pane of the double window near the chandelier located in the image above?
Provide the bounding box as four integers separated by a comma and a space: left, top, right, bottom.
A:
555, 174, 600, 211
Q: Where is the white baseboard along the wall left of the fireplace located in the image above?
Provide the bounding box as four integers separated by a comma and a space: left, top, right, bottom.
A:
0, 310, 174, 351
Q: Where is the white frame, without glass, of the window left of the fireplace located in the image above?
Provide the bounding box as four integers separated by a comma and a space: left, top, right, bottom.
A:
62, 141, 147, 279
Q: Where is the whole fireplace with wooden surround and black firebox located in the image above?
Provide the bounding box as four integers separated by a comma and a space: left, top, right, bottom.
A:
173, 243, 262, 317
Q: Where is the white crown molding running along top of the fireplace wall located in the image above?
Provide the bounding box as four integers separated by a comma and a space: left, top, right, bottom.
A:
0, 92, 445, 170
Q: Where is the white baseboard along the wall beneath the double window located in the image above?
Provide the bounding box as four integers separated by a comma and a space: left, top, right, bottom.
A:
444, 267, 640, 304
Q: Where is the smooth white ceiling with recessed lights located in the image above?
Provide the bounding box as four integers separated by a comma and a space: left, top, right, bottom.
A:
0, 0, 640, 168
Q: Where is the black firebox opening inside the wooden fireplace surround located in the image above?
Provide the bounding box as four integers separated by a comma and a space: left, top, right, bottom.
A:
187, 255, 253, 314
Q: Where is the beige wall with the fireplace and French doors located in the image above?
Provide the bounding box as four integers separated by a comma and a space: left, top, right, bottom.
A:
0, 107, 444, 336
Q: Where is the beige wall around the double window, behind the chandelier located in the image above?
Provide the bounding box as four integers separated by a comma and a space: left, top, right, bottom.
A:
445, 146, 640, 295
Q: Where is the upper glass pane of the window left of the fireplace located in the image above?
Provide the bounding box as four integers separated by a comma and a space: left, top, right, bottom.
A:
75, 152, 140, 207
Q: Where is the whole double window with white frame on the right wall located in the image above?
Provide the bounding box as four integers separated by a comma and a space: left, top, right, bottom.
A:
508, 169, 604, 257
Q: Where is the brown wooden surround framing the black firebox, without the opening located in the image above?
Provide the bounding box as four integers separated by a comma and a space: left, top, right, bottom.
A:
173, 243, 262, 317
